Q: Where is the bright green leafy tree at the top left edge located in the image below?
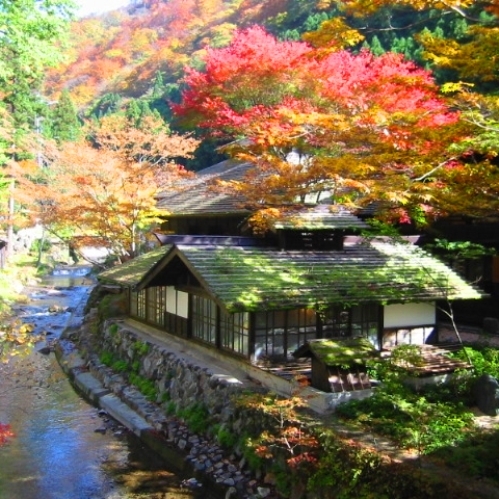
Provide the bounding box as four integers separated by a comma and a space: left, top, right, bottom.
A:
0, 0, 75, 256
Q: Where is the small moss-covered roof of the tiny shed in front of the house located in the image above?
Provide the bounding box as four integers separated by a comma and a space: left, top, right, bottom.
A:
293, 338, 379, 366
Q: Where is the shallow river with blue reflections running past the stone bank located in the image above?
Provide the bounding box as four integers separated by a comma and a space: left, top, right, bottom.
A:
0, 269, 206, 499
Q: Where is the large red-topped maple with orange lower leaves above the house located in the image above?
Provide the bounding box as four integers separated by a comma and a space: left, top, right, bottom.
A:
174, 27, 459, 229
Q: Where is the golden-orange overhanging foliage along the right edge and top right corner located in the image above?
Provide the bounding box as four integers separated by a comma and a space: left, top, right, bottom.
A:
304, 0, 499, 223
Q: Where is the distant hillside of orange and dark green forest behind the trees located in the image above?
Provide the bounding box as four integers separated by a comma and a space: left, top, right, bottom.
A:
45, 0, 491, 116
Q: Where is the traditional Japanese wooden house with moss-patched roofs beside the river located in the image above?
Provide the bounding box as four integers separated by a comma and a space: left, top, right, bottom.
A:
99, 162, 483, 372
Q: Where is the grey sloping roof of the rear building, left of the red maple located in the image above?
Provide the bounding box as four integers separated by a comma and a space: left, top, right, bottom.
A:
157, 160, 250, 215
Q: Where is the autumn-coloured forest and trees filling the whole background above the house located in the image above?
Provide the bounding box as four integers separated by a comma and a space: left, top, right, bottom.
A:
0, 0, 499, 264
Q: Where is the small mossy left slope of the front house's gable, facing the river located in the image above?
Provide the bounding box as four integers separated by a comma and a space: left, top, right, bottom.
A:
97, 245, 172, 287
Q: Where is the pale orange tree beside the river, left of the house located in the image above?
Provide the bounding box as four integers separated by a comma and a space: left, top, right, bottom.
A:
11, 116, 198, 258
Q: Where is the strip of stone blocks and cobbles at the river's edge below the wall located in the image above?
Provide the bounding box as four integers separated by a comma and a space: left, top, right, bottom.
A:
55, 310, 278, 499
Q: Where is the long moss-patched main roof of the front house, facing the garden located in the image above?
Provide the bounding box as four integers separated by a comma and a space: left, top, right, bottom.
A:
100, 241, 482, 312
